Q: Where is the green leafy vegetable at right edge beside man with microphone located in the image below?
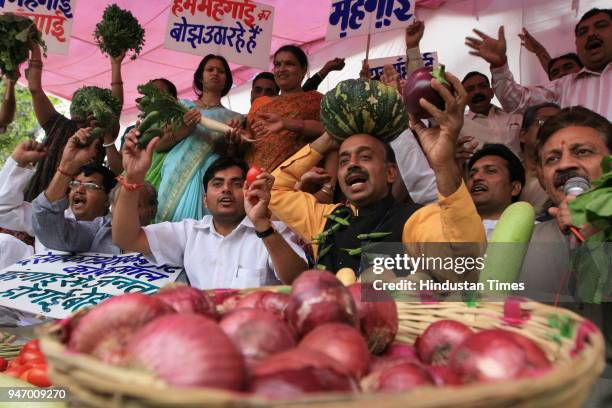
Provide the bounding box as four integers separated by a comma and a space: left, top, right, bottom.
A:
569, 156, 612, 303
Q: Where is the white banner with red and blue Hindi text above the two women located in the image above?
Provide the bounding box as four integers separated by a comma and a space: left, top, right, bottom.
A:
164, 0, 274, 70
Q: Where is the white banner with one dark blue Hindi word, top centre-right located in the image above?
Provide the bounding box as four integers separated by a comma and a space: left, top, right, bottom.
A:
325, 0, 415, 41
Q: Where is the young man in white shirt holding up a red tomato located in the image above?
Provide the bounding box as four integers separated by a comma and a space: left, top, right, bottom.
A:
113, 130, 307, 289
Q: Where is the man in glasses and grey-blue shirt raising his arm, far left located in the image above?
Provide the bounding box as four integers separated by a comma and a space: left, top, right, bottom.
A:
32, 128, 157, 254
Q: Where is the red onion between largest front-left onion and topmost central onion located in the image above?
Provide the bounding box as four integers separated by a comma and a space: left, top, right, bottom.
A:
220, 309, 296, 367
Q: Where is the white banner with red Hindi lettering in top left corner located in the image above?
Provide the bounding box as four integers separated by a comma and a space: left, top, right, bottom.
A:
0, 0, 76, 55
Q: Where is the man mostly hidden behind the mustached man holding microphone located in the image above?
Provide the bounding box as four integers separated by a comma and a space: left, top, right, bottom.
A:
519, 102, 561, 220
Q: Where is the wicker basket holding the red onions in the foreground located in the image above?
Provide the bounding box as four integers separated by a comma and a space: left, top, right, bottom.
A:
42, 301, 604, 408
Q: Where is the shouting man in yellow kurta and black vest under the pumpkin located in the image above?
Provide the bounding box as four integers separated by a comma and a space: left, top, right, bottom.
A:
270, 74, 485, 281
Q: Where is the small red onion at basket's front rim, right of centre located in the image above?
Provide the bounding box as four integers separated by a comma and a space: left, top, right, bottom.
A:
361, 363, 433, 392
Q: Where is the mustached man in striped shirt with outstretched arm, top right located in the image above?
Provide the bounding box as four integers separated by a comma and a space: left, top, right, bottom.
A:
466, 8, 612, 120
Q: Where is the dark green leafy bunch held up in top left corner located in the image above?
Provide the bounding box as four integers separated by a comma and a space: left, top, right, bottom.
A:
0, 13, 47, 80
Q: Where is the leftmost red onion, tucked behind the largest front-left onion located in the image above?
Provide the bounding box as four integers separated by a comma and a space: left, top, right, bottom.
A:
68, 293, 174, 364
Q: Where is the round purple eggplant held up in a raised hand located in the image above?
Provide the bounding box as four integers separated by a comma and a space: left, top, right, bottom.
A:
402, 65, 452, 119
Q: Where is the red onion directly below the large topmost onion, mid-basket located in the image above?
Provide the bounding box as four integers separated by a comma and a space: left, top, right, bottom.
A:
299, 323, 370, 380
